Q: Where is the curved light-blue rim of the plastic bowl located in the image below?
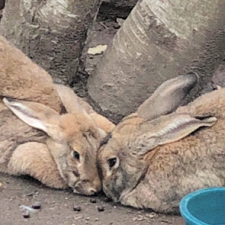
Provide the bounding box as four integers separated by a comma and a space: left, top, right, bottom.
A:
179, 187, 225, 225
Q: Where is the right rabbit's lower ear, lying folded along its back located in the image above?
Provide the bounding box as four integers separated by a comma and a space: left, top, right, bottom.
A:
136, 114, 217, 155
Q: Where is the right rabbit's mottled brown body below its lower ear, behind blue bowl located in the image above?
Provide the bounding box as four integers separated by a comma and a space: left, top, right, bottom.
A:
132, 121, 225, 212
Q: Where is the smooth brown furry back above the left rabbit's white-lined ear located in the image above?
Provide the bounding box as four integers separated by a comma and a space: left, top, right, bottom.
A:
0, 36, 61, 112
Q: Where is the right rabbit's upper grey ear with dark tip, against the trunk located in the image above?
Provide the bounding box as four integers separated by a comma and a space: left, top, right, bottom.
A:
137, 73, 198, 120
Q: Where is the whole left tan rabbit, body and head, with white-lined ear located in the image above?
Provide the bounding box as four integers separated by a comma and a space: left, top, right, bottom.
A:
0, 37, 113, 195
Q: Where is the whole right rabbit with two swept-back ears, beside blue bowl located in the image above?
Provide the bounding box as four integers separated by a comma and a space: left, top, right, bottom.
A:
98, 74, 225, 213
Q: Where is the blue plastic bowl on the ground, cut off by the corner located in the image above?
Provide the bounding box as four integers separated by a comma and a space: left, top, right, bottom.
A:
180, 187, 225, 225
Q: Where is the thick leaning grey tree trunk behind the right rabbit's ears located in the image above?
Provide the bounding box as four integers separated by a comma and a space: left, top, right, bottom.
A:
88, 0, 225, 121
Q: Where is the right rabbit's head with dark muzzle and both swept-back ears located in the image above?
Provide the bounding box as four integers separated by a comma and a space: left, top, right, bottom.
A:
97, 74, 216, 202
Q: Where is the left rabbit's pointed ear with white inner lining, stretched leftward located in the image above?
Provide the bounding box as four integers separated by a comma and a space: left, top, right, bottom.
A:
3, 98, 59, 136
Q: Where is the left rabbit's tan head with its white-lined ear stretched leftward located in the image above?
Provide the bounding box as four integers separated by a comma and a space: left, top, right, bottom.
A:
3, 98, 105, 195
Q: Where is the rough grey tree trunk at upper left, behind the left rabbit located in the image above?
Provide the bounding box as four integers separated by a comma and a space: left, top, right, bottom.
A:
0, 0, 99, 83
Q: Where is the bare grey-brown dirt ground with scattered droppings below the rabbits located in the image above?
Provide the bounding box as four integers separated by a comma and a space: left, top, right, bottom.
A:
0, 173, 185, 225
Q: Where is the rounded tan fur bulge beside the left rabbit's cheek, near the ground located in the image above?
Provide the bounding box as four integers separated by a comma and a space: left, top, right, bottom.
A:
8, 142, 68, 188
